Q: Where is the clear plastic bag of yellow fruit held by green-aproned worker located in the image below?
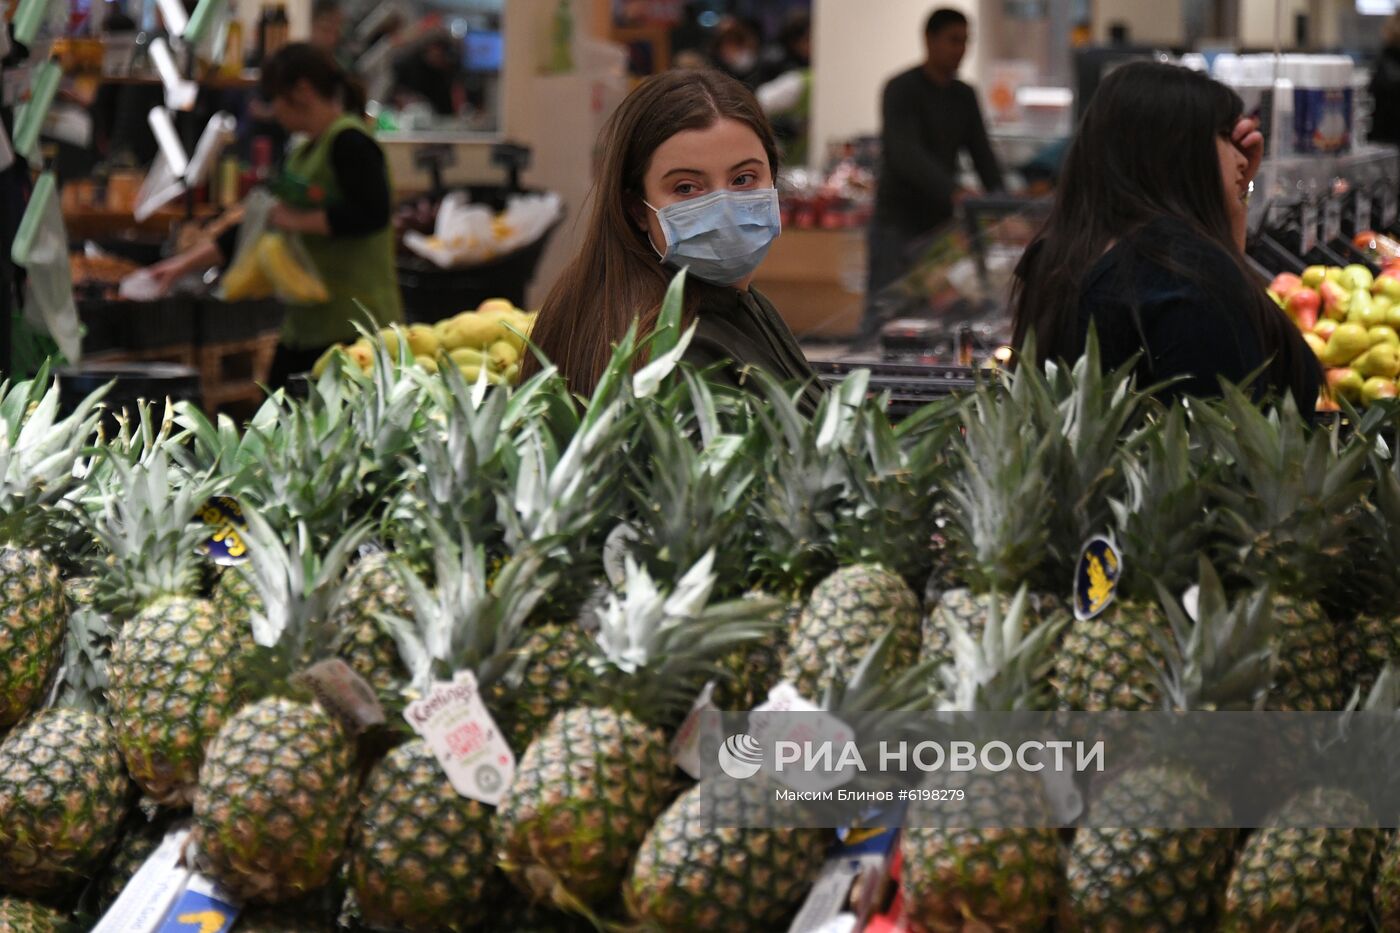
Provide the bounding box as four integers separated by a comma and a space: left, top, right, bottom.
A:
218, 188, 330, 304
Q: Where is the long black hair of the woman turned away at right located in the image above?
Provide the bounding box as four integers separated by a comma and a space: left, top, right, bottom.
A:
1012, 62, 1319, 401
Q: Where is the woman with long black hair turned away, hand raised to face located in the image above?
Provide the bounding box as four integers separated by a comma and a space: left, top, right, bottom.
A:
1014, 63, 1320, 412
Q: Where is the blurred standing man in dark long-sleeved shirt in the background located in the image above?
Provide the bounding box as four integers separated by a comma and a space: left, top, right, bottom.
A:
862, 8, 1001, 338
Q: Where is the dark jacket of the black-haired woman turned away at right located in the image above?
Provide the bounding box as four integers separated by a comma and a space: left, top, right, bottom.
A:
1056, 220, 1319, 413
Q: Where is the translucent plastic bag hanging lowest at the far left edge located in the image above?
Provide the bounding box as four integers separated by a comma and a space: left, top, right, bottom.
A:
10, 172, 83, 363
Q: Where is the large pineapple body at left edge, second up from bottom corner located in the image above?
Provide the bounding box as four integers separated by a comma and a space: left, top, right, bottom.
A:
0, 709, 132, 897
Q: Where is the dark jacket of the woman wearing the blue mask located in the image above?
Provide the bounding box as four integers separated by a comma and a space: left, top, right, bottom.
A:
685, 283, 822, 415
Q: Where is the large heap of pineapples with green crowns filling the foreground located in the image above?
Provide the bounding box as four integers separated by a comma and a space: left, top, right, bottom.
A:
0, 285, 1400, 932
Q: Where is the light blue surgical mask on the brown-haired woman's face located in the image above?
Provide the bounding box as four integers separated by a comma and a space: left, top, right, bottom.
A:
643, 188, 783, 286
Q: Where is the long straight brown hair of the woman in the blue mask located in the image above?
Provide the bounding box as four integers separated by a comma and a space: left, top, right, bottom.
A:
522, 70, 778, 395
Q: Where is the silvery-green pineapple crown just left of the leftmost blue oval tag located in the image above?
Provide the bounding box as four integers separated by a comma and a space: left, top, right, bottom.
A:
84, 443, 224, 616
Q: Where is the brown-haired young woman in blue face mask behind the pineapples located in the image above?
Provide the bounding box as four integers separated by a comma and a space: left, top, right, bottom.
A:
524, 71, 820, 410
